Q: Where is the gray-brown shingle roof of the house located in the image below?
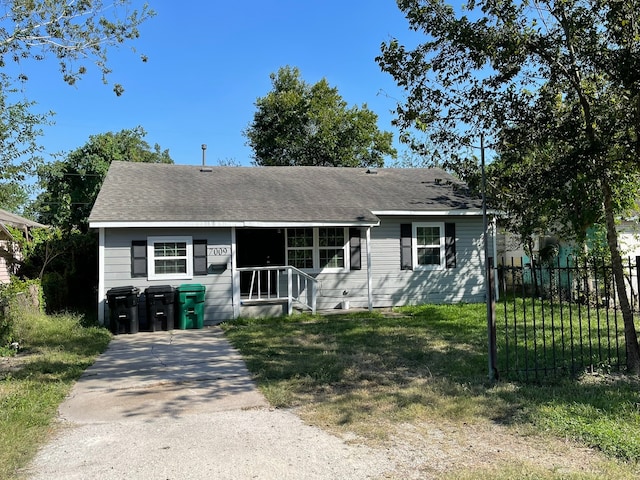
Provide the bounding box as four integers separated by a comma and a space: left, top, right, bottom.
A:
89, 162, 481, 223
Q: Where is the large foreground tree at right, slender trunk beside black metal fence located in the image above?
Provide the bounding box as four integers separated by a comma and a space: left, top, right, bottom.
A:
377, 0, 640, 374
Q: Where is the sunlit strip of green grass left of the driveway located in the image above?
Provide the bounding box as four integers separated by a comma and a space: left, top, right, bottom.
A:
0, 313, 111, 479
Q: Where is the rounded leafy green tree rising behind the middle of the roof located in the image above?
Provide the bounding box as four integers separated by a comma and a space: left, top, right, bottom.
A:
244, 67, 396, 167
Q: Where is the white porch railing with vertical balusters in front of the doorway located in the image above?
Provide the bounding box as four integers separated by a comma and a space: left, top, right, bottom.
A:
238, 265, 318, 315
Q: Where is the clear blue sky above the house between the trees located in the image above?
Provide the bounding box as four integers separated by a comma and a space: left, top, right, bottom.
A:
24, 0, 416, 165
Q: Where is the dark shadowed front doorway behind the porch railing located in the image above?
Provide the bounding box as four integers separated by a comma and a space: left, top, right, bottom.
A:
236, 228, 286, 294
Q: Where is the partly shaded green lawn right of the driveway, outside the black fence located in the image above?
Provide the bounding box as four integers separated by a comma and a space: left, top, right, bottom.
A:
223, 305, 640, 478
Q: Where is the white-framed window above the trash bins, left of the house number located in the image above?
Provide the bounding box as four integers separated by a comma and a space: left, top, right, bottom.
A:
147, 237, 193, 280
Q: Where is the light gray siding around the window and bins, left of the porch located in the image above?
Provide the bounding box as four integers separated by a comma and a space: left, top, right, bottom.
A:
102, 228, 233, 325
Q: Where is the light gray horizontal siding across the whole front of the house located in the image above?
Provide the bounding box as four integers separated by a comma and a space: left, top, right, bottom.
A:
102, 216, 493, 325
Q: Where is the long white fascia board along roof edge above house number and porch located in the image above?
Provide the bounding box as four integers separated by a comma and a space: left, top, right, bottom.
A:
89, 220, 380, 228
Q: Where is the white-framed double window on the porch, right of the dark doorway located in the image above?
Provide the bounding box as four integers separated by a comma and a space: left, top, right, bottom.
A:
287, 227, 350, 270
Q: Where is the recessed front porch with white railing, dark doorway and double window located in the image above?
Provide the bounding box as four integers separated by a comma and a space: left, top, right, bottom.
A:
233, 226, 373, 317
